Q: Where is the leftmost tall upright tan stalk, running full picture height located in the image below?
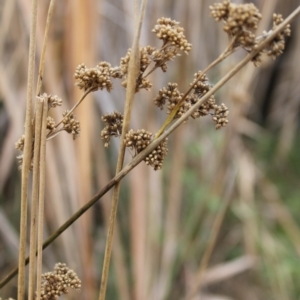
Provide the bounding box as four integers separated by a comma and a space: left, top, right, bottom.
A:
18, 0, 38, 300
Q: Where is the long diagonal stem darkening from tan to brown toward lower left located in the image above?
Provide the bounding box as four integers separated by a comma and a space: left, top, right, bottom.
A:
0, 6, 300, 288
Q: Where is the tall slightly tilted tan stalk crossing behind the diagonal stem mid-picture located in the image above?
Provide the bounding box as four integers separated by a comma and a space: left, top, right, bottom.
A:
99, 0, 147, 300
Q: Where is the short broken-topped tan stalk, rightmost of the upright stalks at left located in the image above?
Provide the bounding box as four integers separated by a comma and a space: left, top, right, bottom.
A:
36, 100, 48, 300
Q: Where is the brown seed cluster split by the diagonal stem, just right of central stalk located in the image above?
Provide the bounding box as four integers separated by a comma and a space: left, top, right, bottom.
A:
125, 129, 168, 171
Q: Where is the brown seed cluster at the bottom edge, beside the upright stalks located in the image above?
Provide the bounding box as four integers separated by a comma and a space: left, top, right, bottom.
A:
41, 263, 81, 300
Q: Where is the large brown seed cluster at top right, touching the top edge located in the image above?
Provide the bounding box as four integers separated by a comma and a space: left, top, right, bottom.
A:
210, 0, 262, 50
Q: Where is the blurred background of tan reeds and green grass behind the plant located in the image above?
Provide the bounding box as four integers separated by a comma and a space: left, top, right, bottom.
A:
0, 0, 300, 300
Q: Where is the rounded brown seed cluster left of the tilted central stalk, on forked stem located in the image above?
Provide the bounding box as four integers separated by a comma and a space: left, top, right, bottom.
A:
74, 61, 113, 92
